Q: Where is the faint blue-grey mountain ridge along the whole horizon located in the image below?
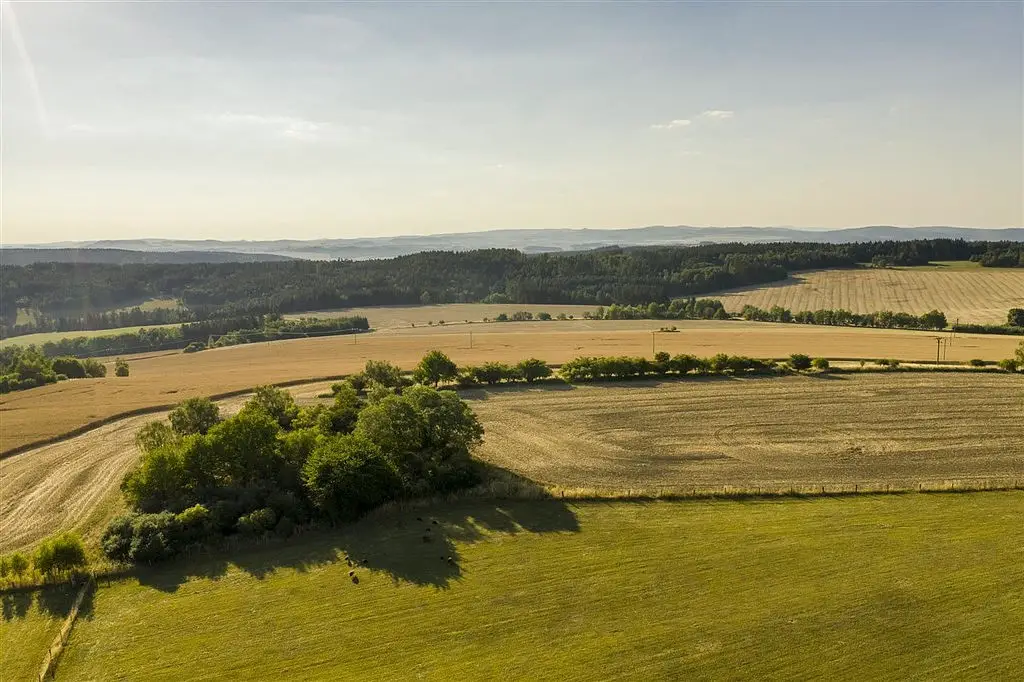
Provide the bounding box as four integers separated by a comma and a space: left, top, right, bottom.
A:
9, 225, 1024, 262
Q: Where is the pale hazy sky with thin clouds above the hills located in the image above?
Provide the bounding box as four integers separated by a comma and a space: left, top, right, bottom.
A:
2, 0, 1024, 244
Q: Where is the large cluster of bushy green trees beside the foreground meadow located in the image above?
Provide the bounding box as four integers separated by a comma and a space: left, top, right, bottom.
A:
101, 363, 483, 562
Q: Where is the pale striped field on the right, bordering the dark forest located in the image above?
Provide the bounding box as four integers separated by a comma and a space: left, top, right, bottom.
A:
709, 267, 1024, 325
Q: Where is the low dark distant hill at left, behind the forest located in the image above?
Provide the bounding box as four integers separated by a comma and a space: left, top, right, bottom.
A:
0, 246, 293, 265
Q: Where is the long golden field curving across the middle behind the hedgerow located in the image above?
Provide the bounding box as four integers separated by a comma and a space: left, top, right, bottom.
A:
0, 321, 1021, 452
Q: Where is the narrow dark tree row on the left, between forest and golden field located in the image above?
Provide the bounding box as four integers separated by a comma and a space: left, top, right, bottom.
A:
42, 315, 370, 357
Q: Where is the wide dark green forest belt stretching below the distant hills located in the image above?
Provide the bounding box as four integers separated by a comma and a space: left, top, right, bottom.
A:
0, 240, 1020, 334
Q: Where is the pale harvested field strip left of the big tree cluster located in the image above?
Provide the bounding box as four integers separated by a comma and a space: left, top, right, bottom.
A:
0, 383, 330, 552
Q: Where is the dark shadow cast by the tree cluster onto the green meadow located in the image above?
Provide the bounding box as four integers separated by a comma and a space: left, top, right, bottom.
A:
135, 470, 580, 592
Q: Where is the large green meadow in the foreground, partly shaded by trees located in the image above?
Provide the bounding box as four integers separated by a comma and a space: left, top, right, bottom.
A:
56, 493, 1024, 680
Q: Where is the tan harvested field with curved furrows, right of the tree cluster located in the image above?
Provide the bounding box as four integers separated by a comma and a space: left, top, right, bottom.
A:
467, 374, 1024, 492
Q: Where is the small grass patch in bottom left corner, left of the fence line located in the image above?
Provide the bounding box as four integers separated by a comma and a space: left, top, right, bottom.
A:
0, 588, 76, 682
